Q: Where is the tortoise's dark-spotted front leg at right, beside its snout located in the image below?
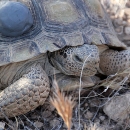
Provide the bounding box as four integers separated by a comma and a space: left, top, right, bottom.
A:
99, 49, 130, 75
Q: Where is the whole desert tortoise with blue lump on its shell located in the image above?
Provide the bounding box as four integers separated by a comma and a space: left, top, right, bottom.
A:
0, 0, 130, 118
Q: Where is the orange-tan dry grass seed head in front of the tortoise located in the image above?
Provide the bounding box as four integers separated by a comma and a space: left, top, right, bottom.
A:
50, 81, 76, 130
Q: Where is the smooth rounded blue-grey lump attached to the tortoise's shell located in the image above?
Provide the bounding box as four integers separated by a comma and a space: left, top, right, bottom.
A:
0, 1, 33, 37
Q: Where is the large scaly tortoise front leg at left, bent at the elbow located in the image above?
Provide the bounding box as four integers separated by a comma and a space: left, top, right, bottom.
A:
0, 64, 50, 118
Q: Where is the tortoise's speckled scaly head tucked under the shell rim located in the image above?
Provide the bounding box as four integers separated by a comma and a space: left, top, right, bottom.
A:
49, 44, 99, 76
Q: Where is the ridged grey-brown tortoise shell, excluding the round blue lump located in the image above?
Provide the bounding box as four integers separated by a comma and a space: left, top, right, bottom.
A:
0, 0, 126, 66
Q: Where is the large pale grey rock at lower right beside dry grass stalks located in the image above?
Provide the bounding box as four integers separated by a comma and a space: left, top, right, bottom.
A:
103, 92, 130, 122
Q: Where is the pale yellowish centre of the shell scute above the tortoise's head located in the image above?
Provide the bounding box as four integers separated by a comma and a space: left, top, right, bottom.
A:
45, 0, 79, 24
